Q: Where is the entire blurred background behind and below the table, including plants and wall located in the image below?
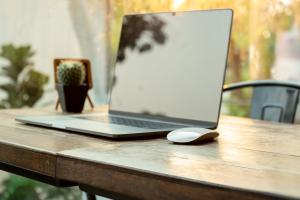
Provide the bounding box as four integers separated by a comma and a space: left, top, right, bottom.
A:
0, 0, 300, 200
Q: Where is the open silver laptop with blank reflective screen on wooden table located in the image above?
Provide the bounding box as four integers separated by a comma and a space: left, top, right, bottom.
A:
16, 9, 233, 138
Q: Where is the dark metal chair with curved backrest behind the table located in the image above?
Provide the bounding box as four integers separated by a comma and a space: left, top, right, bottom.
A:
223, 80, 300, 123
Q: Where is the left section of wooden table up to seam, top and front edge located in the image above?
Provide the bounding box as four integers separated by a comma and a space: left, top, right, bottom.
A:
0, 109, 106, 178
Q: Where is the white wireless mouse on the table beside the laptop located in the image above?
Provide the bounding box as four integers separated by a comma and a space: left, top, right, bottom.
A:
167, 127, 219, 143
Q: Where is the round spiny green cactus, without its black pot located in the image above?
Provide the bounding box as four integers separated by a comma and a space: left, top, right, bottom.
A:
57, 61, 86, 85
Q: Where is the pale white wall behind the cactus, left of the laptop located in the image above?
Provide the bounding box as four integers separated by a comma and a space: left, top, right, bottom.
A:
0, 0, 106, 106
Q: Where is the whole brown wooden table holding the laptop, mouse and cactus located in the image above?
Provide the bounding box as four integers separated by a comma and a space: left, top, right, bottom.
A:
0, 110, 300, 199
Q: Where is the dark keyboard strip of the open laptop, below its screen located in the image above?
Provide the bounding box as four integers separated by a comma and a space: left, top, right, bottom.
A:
76, 116, 185, 129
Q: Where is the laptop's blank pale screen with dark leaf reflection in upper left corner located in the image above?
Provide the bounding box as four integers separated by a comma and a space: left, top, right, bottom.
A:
110, 10, 232, 122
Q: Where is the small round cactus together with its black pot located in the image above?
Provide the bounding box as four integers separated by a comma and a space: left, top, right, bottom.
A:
56, 60, 89, 113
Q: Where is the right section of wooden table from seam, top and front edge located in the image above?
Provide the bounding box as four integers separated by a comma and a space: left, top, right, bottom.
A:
57, 117, 300, 199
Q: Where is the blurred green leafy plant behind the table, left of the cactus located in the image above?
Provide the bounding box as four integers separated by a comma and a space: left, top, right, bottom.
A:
0, 44, 48, 108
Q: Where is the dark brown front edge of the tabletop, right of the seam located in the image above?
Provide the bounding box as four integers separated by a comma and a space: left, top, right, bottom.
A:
58, 158, 298, 200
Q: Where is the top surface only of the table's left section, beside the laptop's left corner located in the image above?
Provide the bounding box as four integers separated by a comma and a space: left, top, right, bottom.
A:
0, 110, 108, 155
